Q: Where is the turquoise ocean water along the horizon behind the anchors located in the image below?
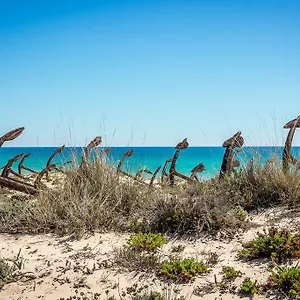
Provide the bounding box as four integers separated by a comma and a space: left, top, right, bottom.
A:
0, 147, 300, 179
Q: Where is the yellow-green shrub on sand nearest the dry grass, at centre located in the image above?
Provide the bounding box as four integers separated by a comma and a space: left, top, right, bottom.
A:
128, 232, 167, 252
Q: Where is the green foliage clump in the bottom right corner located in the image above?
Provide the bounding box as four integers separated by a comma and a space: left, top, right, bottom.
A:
266, 266, 300, 297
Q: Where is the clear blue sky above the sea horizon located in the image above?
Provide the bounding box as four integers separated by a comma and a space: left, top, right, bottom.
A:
0, 0, 300, 146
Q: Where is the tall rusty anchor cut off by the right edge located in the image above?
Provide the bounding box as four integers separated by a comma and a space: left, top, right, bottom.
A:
282, 116, 300, 172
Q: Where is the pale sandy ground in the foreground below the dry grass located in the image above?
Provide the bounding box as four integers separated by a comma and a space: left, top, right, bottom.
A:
0, 209, 300, 300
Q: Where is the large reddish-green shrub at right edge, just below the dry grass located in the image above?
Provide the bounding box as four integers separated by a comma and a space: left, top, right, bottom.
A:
239, 227, 300, 262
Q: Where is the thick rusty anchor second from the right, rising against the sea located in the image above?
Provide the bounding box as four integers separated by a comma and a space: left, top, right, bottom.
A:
220, 131, 244, 178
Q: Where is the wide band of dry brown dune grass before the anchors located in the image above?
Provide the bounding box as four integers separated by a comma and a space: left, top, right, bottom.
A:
0, 158, 300, 236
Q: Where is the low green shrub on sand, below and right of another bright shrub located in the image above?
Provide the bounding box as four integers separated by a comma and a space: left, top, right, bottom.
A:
161, 258, 209, 283
